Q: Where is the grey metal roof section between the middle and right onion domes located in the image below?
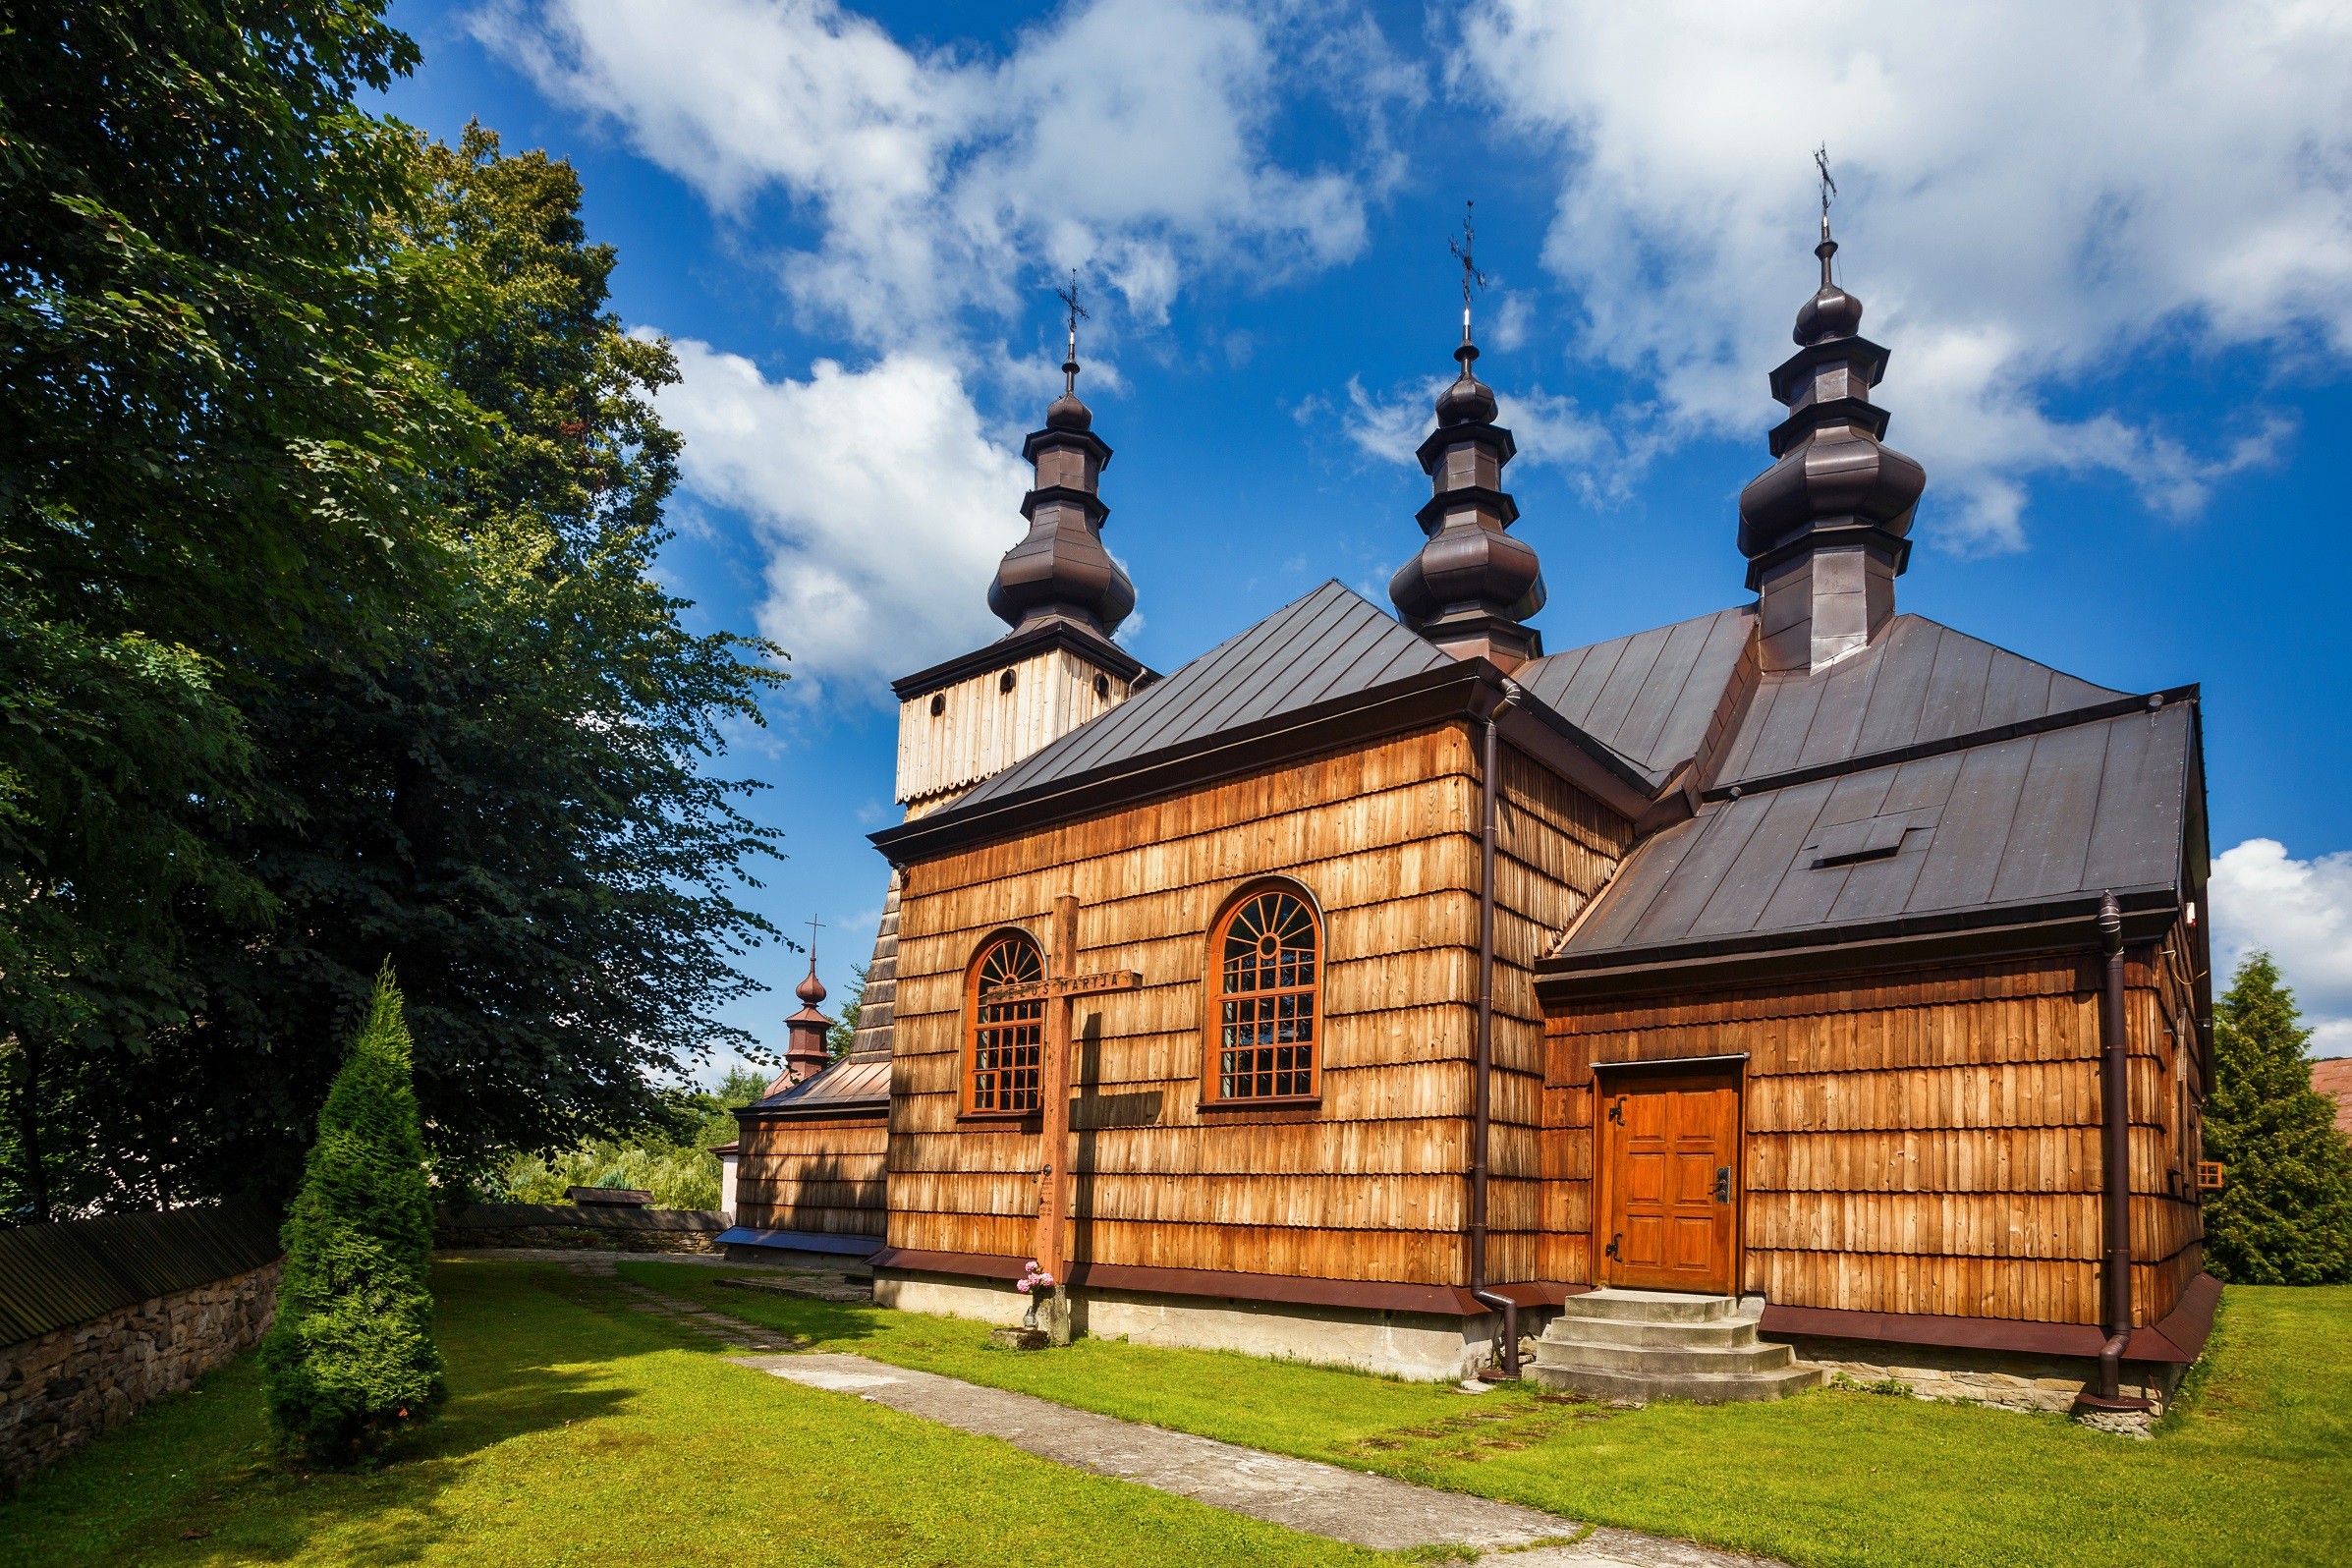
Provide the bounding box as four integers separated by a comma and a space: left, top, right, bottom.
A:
1515, 604, 1757, 792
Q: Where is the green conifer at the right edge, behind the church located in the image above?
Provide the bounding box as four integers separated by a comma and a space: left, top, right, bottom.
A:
2204, 952, 2352, 1286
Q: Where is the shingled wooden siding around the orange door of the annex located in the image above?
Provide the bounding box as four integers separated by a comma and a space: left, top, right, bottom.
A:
1545, 950, 2199, 1323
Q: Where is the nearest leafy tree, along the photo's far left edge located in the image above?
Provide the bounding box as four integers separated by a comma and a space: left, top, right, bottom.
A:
0, 0, 471, 1215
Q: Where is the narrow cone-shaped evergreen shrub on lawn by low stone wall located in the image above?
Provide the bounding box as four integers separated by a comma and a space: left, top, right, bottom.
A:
261, 966, 444, 1467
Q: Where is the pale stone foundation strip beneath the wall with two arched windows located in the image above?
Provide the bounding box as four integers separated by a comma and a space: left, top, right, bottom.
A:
875, 1269, 1531, 1382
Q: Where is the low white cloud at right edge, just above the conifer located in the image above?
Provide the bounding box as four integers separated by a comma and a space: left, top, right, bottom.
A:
2209, 839, 2352, 1055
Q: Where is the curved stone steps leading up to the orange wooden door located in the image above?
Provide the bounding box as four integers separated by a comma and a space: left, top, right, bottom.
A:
1529, 1291, 1822, 1404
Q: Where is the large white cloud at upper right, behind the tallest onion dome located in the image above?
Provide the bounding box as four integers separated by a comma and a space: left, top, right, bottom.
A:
1453, 0, 2352, 548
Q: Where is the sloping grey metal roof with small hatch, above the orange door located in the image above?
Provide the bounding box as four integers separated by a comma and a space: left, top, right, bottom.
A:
1547, 700, 2195, 969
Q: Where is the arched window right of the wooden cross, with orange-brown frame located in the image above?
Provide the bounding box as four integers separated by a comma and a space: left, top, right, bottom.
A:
1204, 886, 1321, 1100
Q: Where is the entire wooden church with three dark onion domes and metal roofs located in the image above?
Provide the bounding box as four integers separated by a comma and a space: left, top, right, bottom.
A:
729, 221, 2218, 1413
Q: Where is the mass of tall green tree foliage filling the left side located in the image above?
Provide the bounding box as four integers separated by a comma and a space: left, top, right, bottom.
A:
0, 12, 783, 1215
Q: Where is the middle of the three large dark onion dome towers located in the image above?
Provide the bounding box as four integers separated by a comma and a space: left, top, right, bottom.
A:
1387, 204, 1545, 670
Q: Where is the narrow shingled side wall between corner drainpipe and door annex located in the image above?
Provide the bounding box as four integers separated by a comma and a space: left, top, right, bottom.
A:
1486, 746, 1632, 1281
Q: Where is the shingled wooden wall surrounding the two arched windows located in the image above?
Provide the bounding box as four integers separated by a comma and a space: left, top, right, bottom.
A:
889, 724, 1480, 1283
